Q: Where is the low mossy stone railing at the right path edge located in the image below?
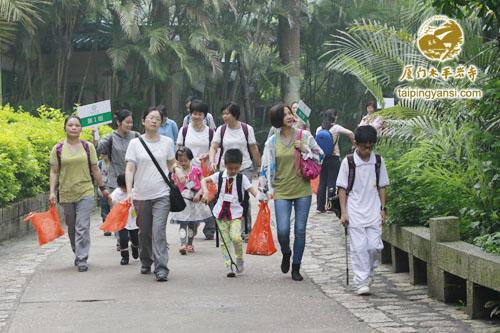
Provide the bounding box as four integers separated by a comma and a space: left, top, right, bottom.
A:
382, 217, 500, 319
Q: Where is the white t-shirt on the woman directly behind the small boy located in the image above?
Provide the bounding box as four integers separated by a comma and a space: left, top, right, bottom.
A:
212, 125, 257, 170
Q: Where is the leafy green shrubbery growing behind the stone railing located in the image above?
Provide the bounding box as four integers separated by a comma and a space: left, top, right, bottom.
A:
379, 122, 500, 251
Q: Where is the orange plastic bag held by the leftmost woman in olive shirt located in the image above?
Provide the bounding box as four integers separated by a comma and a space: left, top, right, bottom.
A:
24, 204, 64, 246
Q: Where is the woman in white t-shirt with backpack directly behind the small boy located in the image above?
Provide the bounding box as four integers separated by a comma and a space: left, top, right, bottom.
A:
209, 102, 261, 241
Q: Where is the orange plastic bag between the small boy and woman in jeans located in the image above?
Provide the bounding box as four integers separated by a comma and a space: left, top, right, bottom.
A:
247, 201, 276, 256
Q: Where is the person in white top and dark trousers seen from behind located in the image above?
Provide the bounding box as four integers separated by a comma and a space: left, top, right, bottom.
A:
316, 109, 354, 214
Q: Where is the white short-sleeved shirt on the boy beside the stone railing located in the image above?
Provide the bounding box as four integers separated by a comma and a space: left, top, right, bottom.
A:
337, 152, 389, 227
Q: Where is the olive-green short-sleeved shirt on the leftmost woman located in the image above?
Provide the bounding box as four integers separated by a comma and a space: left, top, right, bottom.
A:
50, 142, 97, 203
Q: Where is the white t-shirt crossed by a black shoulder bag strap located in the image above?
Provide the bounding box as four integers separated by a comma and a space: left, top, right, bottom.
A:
125, 135, 175, 200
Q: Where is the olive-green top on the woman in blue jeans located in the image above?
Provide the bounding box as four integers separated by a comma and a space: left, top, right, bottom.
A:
274, 134, 311, 199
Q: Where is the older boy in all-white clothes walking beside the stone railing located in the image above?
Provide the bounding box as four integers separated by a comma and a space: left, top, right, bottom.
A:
337, 125, 389, 295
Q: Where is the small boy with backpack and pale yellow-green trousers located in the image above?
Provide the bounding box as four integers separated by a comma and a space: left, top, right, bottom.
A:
201, 149, 257, 278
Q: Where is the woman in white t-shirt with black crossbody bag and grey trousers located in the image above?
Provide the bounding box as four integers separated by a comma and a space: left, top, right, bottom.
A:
125, 107, 175, 281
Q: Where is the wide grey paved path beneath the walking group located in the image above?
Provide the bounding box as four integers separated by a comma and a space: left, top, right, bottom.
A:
0, 198, 374, 332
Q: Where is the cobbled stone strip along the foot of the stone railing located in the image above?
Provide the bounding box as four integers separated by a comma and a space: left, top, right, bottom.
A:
304, 212, 500, 333
